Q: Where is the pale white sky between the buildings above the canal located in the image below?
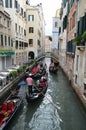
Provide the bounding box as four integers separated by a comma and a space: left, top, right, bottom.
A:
29, 0, 62, 35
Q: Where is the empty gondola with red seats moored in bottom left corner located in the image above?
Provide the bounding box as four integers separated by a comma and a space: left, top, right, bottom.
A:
0, 92, 23, 130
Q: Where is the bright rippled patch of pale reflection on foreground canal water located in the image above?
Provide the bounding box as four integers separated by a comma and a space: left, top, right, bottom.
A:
28, 93, 61, 130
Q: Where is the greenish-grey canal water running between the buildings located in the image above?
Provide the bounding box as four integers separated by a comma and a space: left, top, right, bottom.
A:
6, 58, 86, 130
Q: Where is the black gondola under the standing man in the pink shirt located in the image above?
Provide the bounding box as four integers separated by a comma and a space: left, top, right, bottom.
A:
26, 76, 48, 103
